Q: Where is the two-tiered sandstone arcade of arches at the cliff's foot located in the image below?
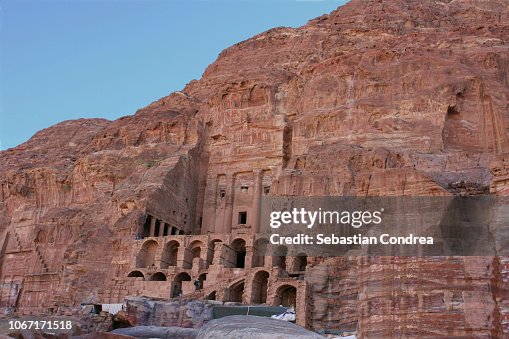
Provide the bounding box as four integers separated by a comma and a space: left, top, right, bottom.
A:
101, 233, 309, 325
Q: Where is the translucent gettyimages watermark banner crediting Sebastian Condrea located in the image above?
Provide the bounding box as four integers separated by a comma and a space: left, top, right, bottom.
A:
258, 195, 509, 256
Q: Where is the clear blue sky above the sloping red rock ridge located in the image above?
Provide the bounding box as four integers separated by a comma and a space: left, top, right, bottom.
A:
0, 0, 346, 149
